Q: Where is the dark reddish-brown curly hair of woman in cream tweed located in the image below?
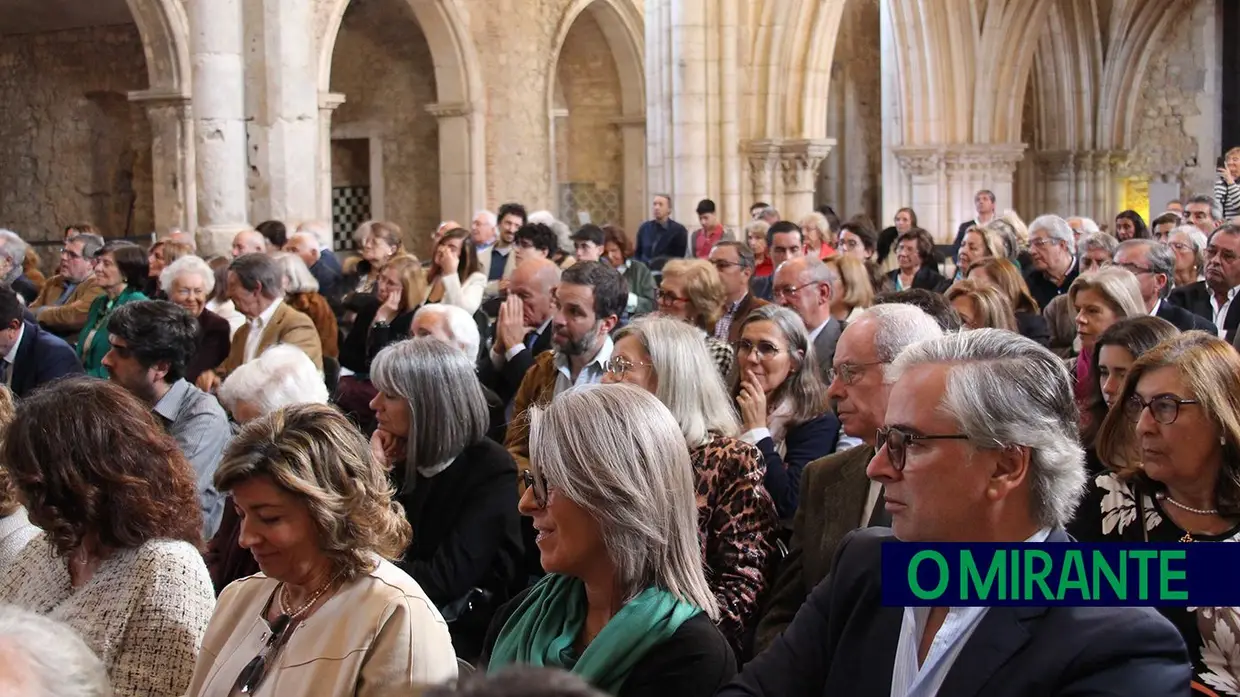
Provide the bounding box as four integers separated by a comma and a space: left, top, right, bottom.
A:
0, 377, 202, 556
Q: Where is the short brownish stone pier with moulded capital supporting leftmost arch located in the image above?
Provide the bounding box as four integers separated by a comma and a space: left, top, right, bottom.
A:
129, 91, 198, 233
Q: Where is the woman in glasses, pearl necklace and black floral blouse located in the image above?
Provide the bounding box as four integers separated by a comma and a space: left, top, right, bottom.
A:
1069, 329, 1240, 695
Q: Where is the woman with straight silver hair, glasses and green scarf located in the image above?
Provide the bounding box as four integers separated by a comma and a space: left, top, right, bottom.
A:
482, 384, 737, 697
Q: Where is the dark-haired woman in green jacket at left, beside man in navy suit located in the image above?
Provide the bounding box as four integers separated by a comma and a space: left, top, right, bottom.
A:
77, 239, 149, 377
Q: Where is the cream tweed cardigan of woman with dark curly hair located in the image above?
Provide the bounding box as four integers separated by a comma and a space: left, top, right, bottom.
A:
0, 533, 216, 697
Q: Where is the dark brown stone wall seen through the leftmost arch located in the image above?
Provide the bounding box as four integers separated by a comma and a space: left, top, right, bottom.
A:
0, 25, 154, 246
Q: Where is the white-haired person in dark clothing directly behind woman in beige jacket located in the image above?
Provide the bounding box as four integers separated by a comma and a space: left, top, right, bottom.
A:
203, 344, 327, 594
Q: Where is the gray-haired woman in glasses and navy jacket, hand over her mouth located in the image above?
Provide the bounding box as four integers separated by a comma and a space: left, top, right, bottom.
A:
732, 305, 839, 521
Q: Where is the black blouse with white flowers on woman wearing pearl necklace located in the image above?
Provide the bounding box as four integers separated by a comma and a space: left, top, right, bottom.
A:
1068, 473, 1240, 697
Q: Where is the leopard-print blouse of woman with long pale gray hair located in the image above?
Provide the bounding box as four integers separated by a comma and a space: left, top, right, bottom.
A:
689, 435, 779, 649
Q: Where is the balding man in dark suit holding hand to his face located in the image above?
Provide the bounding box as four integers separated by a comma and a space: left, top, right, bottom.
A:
479, 258, 559, 404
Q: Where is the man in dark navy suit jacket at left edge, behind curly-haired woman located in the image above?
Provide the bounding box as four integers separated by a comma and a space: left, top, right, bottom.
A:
0, 286, 82, 398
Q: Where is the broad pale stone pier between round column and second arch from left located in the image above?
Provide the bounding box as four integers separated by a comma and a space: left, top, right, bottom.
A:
248, 0, 322, 224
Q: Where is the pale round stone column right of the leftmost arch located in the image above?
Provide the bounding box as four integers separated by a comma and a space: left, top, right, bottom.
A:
188, 0, 249, 255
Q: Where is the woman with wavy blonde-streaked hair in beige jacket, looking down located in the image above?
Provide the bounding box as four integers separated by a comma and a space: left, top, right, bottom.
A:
187, 404, 456, 697
